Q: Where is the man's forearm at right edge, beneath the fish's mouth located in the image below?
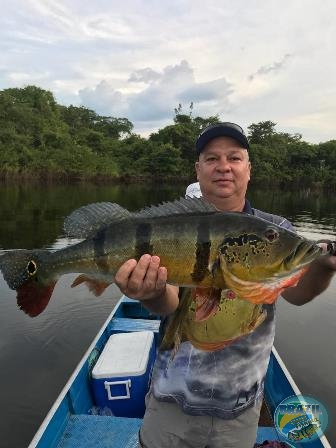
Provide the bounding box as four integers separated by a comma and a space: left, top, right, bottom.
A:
282, 255, 336, 305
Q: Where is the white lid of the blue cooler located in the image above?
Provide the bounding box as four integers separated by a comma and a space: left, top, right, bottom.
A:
92, 331, 154, 379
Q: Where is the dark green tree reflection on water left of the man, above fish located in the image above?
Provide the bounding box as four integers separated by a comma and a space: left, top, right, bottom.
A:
0, 184, 185, 249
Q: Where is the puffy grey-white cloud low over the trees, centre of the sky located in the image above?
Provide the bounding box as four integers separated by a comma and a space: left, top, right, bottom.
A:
79, 60, 232, 127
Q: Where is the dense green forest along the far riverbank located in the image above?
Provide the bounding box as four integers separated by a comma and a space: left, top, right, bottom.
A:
0, 86, 336, 189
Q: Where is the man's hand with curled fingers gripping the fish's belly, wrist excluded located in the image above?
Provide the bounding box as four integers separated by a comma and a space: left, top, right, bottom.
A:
115, 254, 167, 300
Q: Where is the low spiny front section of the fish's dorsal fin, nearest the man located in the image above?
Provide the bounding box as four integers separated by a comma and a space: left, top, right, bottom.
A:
133, 198, 218, 218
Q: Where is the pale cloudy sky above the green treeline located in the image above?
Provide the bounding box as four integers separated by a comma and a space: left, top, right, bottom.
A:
0, 0, 336, 143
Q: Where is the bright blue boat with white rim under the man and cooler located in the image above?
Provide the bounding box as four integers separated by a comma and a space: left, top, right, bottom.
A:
28, 296, 331, 448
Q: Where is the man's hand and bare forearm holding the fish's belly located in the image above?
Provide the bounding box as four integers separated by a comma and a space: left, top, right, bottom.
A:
115, 254, 179, 316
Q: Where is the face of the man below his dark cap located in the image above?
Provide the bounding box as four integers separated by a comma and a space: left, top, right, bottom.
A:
195, 137, 251, 203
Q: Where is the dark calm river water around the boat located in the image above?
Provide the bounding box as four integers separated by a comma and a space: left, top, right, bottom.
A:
0, 184, 336, 448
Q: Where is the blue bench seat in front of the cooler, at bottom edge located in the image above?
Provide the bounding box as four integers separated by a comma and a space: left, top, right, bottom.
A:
57, 415, 142, 448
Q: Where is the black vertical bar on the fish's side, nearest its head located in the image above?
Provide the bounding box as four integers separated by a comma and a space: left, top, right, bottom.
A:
191, 222, 211, 282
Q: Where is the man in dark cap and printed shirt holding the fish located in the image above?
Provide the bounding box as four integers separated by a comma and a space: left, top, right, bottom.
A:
115, 123, 336, 448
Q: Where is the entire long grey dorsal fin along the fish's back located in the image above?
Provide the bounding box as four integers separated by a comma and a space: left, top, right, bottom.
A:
64, 198, 217, 238
